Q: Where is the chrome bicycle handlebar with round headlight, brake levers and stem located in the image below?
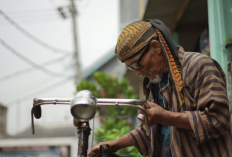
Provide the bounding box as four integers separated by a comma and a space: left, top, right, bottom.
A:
31, 90, 149, 157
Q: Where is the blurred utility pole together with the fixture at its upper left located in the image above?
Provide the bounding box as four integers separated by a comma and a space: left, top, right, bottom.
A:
57, 0, 81, 84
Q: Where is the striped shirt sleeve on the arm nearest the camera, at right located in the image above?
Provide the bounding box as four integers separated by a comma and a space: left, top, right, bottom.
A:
184, 55, 230, 144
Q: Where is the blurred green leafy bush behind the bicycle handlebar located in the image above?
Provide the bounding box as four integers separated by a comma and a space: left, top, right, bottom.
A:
77, 72, 140, 156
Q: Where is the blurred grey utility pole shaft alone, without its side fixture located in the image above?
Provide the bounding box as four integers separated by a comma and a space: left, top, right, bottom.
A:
70, 0, 81, 84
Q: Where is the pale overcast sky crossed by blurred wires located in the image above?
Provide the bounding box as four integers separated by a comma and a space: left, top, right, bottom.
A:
0, 0, 119, 134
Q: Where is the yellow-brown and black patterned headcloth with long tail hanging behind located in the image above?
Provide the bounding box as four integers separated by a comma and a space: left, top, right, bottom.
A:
115, 19, 183, 108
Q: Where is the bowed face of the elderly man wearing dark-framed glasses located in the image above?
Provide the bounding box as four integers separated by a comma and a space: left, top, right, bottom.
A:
125, 40, 167, 80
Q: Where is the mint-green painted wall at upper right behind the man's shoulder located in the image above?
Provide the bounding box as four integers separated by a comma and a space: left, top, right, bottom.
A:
208, 0, 232, 75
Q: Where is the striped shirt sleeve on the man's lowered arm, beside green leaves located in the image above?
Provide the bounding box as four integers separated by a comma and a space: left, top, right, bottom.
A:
127, 124, 150, 156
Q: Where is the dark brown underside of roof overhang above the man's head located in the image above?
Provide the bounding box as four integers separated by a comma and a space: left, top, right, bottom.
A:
143, 0, 208, 51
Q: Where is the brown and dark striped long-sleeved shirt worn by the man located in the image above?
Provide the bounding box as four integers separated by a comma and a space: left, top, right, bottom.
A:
128, 47, 232, 157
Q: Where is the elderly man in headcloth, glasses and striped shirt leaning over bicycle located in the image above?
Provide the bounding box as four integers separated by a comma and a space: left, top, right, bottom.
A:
88, 19, 232, 157
